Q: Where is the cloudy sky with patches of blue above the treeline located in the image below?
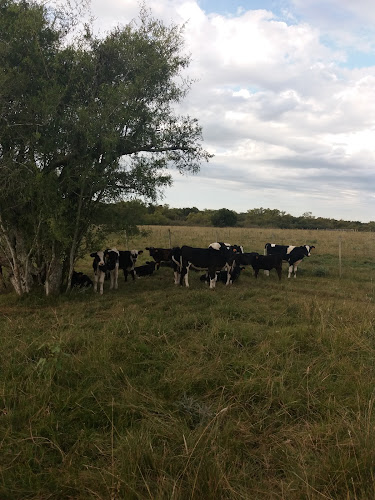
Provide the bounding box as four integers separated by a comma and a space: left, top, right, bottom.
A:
91, 0, 375, 222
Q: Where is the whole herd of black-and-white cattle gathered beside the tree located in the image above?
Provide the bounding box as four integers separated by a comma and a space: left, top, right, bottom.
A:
71, 242, 315, 294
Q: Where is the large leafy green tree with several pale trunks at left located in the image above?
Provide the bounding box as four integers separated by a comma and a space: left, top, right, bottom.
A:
0, 0, 210, 294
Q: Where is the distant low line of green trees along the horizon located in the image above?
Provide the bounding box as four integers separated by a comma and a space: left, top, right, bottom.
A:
102, 200, 375, 231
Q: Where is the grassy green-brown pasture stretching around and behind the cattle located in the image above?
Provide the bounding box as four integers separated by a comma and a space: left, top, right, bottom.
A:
0, 227, 375, 500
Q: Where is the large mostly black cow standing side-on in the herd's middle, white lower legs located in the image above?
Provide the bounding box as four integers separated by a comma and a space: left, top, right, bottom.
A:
172, 245, 241, 289
